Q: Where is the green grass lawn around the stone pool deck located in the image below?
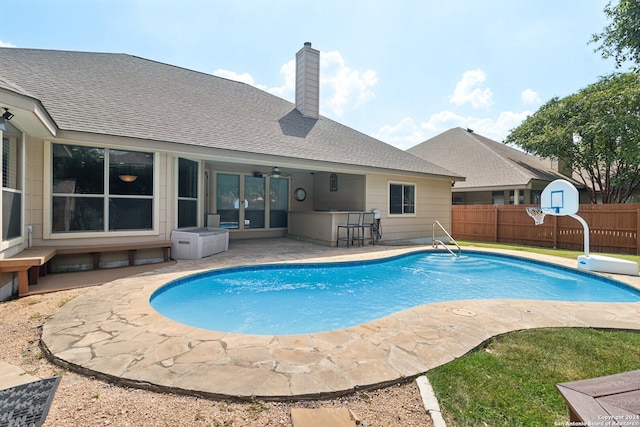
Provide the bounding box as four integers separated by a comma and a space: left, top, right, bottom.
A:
427, 242, 640, 427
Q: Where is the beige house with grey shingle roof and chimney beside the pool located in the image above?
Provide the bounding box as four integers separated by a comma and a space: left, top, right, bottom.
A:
0, 43, 463, 297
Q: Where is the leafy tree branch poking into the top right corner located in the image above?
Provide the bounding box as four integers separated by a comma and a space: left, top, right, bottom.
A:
591, 0, 640, 71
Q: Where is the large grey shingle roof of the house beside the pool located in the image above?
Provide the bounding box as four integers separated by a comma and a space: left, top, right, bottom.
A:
0, 48, 462, 179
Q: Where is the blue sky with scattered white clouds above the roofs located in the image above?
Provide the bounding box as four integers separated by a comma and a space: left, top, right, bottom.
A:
0, 0, 616, 149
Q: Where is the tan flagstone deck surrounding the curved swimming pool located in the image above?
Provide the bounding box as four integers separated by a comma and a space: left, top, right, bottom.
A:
42, 242, 640, 400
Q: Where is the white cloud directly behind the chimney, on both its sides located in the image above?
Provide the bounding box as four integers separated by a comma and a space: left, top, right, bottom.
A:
213, 51, 378, 116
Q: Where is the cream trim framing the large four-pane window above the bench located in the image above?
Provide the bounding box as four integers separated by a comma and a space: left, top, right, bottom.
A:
42, 141, 160, 240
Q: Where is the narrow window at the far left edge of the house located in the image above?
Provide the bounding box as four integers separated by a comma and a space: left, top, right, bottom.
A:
2, 123, 22, 240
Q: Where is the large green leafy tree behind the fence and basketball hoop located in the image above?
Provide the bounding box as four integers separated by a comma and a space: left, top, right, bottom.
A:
505, 73, 640, 203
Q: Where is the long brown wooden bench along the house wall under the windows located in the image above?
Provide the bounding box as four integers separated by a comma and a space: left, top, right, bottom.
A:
0, 240, 171, 296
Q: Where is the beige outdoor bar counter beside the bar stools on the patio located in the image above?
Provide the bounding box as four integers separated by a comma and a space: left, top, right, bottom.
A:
289, 211, 353, 246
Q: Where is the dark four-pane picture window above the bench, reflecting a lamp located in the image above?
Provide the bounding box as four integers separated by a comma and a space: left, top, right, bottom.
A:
51, 144, 154, 233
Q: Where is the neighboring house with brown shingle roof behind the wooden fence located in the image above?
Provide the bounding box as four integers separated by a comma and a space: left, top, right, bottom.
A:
407, 127, 588, 205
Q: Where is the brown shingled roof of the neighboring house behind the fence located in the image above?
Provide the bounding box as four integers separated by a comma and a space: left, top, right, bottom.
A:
407, 127, 578, 190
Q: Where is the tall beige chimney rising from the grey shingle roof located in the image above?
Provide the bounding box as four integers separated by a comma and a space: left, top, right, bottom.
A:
296, 42, 320, 119
